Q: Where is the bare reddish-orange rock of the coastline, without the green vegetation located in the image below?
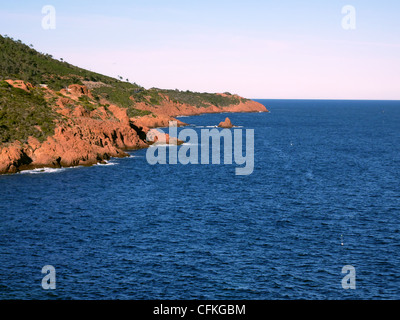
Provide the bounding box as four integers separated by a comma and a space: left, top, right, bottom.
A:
0, 80, 268, 174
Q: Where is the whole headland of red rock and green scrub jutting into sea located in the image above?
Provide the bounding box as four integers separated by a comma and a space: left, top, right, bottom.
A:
0, 36, 268, 174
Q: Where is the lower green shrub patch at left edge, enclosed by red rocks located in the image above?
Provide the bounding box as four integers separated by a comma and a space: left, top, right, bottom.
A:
0, 81, 58, 143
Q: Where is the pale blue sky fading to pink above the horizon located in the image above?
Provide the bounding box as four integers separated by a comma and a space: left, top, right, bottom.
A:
0, 0, 400, 100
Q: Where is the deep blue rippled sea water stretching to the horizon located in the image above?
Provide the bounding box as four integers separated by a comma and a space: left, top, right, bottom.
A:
0, 100, 400, 299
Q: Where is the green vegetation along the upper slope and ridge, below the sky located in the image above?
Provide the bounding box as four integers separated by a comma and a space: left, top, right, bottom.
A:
0, 35, 245, 108
